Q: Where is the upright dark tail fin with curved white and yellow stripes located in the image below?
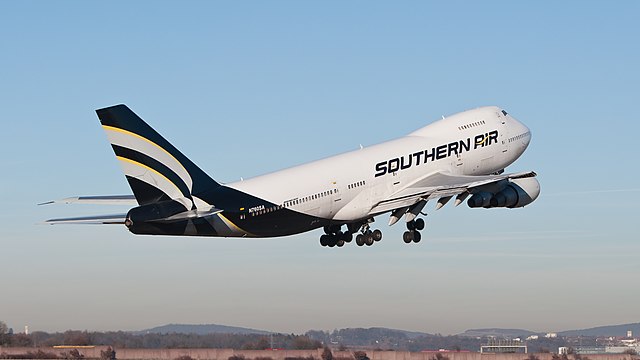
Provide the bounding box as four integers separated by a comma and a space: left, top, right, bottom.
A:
96, 105, 220, 210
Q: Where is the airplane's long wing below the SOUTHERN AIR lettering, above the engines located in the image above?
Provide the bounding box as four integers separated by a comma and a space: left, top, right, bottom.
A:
371, 171, 536, 214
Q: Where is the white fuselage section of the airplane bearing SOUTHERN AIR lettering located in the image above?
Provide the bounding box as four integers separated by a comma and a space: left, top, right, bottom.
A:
226, 106, 531, 221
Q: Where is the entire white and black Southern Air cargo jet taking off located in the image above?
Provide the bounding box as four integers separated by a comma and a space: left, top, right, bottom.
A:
44, 104, 540, 247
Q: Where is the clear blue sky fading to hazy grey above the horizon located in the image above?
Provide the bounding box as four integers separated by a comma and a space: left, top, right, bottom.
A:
0, 1, 640, 334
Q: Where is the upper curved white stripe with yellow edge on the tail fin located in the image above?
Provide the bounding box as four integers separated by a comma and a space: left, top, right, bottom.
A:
102, 125, 193, 196
